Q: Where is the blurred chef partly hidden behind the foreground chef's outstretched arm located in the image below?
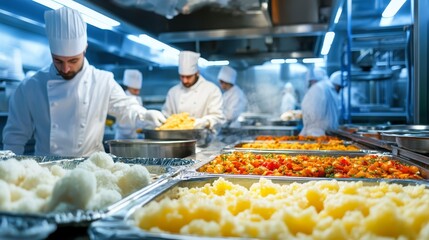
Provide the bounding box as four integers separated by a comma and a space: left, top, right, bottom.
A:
115, 69, 143, 139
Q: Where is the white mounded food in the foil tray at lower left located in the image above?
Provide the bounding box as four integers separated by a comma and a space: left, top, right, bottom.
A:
0, 152, 151, 213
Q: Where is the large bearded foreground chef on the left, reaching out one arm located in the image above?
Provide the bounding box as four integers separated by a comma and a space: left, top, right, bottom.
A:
3, 7, 165, 156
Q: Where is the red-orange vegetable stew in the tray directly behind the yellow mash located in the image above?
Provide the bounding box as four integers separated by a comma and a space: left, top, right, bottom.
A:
197, 151, 424, 180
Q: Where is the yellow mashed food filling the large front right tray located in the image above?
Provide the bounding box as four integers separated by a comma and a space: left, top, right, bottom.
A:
134, 178, 429, 240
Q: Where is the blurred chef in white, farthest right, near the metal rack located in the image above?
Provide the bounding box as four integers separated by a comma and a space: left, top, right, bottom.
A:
300, 71, 344, 136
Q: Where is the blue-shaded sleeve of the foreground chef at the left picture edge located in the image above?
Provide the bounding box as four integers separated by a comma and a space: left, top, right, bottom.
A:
3, 87, 33, 155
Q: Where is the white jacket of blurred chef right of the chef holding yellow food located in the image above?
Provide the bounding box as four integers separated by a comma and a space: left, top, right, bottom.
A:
222, 85, 247, 122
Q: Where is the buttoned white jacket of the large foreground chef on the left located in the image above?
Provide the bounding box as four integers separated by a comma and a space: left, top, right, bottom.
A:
3, 59, 146, 156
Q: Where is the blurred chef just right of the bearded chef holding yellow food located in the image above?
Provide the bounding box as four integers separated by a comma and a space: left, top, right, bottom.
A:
217, 66, 247, 125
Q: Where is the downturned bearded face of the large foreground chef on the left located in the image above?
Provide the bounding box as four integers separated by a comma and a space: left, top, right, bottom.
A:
52, 52, 85, 80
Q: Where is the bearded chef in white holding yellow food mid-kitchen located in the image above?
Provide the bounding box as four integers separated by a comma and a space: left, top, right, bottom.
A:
162, 51, 225, 130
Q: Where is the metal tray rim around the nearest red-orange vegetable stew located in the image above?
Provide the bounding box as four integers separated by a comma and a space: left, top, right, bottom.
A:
191, 149, 429, 180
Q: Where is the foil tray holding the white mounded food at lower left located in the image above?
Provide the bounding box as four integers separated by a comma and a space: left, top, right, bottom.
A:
0, 153, 195, 227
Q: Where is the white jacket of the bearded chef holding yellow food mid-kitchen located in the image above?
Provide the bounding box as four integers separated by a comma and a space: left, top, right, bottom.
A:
162, 75, 225, 129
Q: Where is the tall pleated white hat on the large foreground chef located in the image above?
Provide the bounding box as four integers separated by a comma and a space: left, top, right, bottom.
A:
45, 7, 87, 57
